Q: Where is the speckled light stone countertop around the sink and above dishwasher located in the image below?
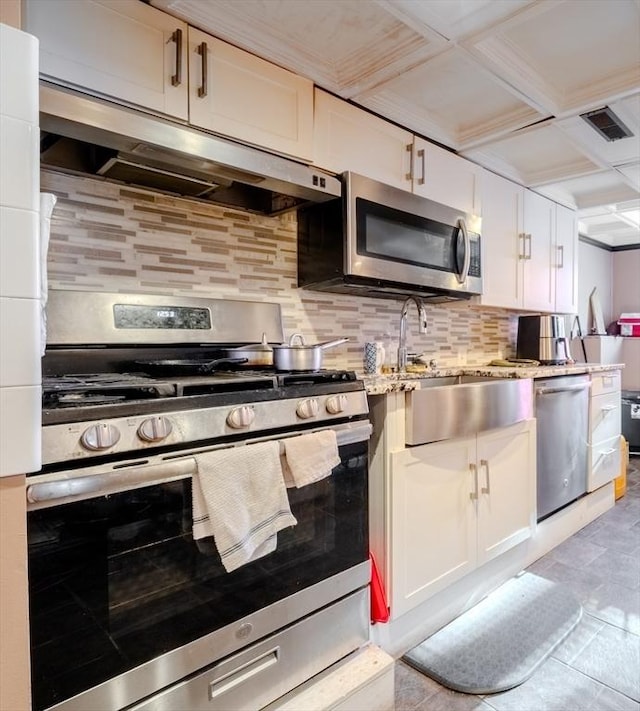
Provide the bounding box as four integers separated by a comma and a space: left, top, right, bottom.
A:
358, 363, 624, 395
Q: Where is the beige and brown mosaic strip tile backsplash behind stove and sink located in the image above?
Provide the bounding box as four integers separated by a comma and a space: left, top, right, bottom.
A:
41, 170, 517, 371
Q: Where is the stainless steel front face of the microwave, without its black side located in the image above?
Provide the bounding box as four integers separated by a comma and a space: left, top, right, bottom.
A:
346, 173, 482, 294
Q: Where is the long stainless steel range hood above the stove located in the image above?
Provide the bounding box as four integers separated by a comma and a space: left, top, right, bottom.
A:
40, 82, 341, 215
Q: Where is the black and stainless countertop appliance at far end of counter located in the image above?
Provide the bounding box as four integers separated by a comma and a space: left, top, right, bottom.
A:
516, 314, 571, 365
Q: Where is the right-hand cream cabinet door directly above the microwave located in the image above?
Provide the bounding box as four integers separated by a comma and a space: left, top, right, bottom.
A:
413, 136, 481, 215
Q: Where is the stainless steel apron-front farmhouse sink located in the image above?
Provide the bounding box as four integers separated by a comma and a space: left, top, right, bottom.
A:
405, 375, 533, 445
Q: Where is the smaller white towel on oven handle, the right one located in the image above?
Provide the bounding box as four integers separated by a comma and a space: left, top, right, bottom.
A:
281, 430, 340, 489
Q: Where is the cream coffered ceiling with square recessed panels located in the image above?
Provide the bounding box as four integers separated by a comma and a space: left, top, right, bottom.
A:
151, 0, 640, 246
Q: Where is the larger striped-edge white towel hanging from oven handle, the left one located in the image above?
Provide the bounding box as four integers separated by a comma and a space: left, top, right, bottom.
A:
193, 441, 297, 573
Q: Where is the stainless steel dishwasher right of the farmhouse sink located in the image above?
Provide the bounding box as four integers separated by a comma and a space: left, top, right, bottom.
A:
535, 375, 591, 521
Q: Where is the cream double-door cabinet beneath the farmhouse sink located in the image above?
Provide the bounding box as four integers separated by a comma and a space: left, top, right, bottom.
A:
390, 420, 536, 618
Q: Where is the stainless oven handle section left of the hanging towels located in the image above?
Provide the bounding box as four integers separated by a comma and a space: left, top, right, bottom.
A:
27, 457, 197, 510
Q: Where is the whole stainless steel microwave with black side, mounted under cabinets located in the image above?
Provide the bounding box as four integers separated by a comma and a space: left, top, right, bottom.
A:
298, 173, 482, 302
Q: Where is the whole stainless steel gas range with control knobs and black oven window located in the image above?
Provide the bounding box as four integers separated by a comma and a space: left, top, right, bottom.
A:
26, 291, 371, 711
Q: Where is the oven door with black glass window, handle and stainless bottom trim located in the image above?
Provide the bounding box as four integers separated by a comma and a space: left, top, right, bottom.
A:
27, 421, 371, 711
